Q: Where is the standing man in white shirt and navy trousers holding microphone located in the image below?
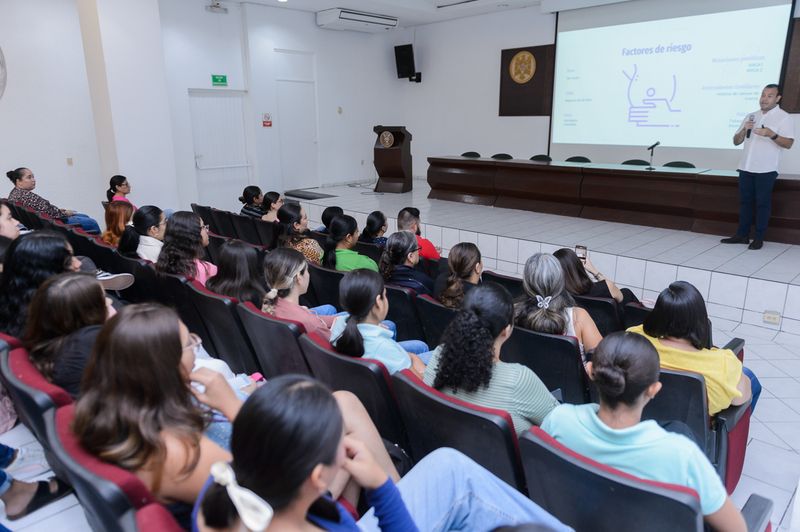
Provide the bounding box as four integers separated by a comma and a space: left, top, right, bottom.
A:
721, 84, 794, 249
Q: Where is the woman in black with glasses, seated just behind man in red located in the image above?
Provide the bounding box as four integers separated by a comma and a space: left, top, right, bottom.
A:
379, 231, 433, 295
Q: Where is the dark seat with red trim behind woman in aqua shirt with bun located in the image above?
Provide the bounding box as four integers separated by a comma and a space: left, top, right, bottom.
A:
519, 427, 772, 532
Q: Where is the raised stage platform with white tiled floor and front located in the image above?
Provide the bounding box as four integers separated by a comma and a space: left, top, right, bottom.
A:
300, 179, 800, 334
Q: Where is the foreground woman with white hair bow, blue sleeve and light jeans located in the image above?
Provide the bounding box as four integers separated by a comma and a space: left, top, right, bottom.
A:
194, 375, 568, 532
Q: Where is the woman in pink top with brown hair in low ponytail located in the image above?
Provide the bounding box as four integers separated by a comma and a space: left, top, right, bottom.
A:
261, 248, 336, 340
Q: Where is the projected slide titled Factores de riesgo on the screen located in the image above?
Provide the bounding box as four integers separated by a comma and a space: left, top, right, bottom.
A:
552, 4, 791, 149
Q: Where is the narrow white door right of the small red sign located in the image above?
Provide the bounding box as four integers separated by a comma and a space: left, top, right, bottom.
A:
276, 80, 319, 190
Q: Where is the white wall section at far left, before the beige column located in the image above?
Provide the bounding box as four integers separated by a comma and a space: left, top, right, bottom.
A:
0, 0, 108, 216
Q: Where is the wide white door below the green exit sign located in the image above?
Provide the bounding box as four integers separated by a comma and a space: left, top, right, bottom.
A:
189, 91, 252, 210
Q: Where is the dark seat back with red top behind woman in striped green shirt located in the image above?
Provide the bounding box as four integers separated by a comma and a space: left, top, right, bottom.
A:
392, 370, 525, 492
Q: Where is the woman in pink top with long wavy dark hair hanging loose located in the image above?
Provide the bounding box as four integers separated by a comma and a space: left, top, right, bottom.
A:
156, 211, 217, 286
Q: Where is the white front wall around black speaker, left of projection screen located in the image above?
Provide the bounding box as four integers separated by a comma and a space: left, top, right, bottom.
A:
376, 6, 555, 176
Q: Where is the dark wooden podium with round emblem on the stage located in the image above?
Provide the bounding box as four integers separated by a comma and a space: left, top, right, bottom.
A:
372, 126, 411, 193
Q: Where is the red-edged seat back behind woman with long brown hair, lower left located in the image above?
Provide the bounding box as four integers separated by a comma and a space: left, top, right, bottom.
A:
46, 405, 181, 532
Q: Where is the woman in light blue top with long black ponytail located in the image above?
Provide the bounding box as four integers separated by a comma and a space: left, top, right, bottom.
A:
331, 270, 430, 377
